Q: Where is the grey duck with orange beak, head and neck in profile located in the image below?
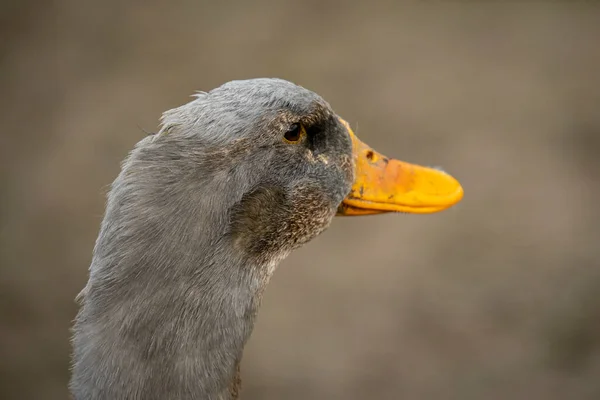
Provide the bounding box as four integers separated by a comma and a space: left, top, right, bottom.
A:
69, 78, 463, 400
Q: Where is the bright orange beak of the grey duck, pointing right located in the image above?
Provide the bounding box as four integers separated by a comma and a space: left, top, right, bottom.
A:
337, 118, 463, 216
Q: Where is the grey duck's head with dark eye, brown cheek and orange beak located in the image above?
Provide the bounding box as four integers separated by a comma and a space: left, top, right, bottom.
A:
155, 79, 463, 262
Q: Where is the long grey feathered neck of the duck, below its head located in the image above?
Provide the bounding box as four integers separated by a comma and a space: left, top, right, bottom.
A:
71, 151, 268, 399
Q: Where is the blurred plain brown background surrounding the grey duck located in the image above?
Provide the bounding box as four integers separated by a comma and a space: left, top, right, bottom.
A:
0, 0, 600, 400
